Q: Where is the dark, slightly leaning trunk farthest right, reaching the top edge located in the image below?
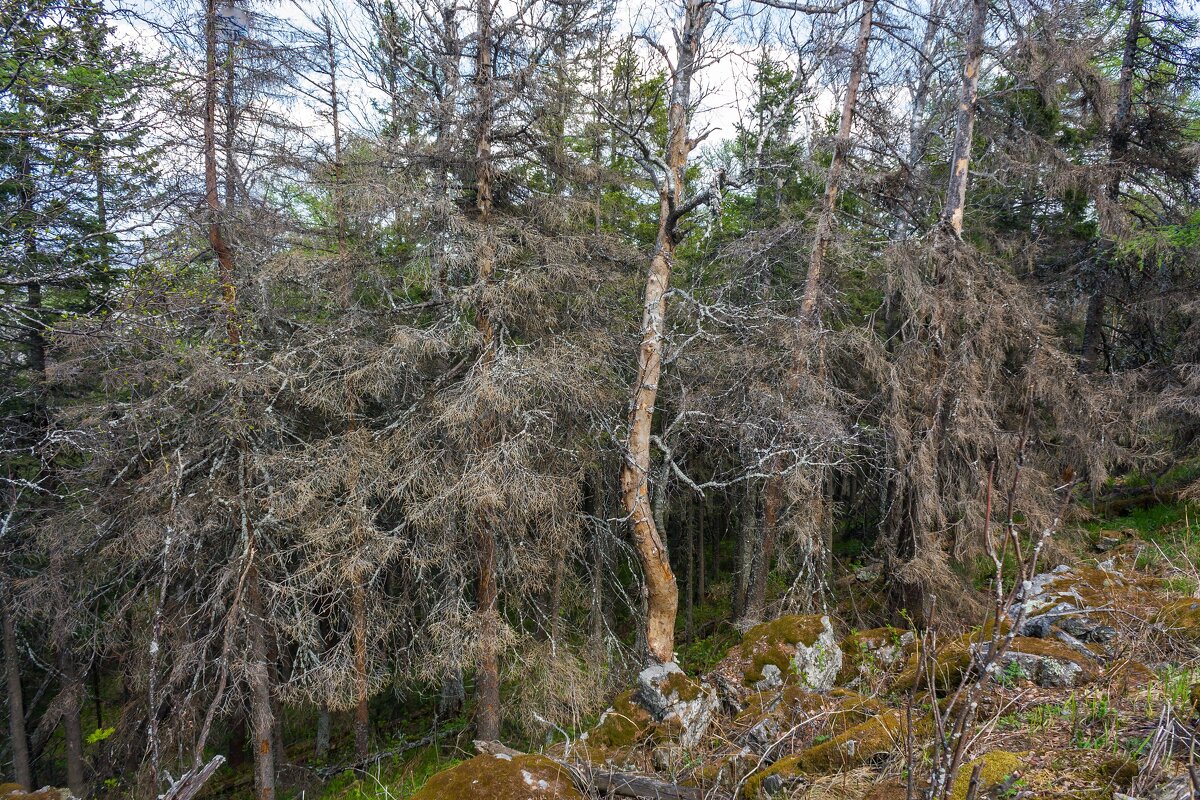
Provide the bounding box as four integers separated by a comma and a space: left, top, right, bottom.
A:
1080, 0, 1145, 372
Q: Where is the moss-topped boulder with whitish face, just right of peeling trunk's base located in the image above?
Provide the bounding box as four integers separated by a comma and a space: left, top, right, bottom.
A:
713, 614, 842, 702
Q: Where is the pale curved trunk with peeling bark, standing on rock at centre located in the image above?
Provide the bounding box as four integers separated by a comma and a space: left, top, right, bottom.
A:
620, 0, 713, 663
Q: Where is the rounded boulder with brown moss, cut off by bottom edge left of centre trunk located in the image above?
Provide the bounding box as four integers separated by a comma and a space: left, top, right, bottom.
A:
413, 754, 583, 800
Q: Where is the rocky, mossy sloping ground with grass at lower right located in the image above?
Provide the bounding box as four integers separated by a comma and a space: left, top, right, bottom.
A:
196, 491, 1200, 800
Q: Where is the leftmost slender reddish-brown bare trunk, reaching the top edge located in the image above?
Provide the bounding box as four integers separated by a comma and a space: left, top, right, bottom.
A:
204, 0, 241, 355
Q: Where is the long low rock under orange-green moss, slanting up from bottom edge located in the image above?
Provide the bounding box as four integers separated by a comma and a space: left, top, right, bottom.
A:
745, 710, 917, 800
